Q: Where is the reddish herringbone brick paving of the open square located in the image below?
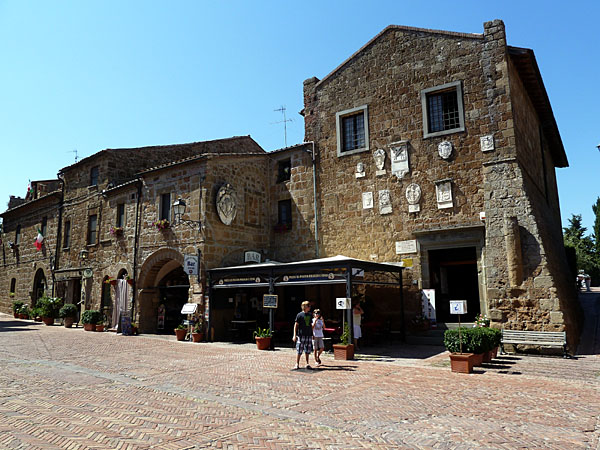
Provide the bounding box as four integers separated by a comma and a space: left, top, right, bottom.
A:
0, 315, 600, 449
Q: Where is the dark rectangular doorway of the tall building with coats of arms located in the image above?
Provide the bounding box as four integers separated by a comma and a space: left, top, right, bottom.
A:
429, 247, 480, 322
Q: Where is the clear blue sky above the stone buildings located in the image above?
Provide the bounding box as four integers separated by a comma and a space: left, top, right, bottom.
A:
0, 0, 600, 234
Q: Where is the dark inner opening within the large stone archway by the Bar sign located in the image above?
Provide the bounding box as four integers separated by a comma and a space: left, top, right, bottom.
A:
158, 266, 190, 334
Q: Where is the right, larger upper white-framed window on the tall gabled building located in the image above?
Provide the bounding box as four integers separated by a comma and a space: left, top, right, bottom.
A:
421, 81, 465, 137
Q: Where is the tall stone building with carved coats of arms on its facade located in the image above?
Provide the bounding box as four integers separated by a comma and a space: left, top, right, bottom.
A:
303, 20, 578, 345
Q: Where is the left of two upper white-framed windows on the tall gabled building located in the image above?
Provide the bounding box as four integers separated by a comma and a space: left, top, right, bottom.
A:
335, 105, 369, 156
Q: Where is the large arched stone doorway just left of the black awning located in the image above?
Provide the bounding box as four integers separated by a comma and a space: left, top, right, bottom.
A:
136, 249, 190, 334
